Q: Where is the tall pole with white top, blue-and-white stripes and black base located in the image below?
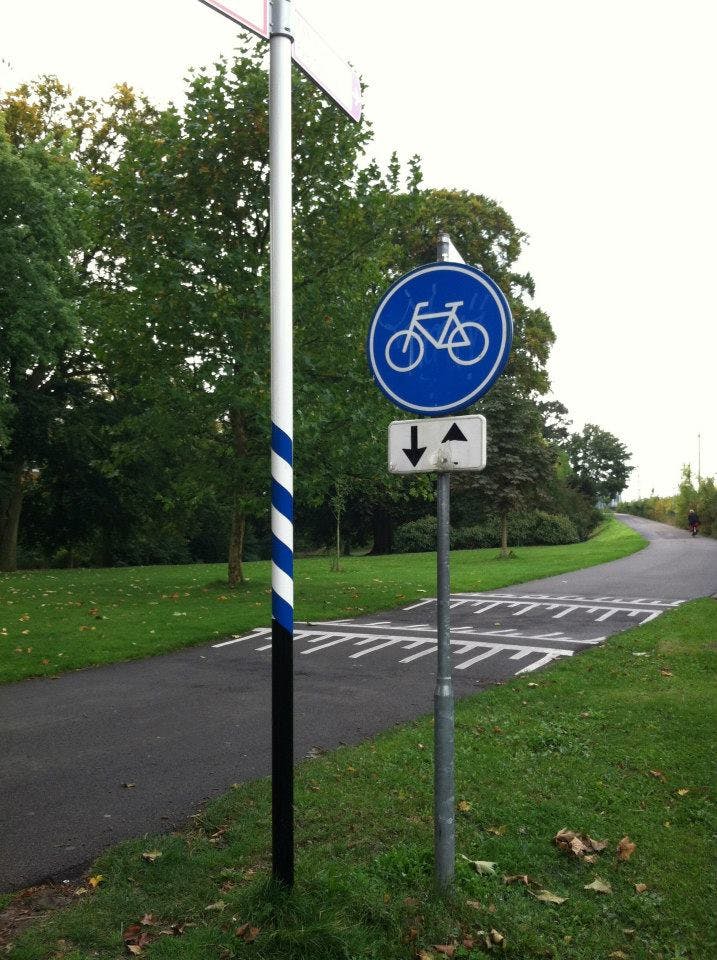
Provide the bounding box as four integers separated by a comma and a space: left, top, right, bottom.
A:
269, 0, 294, 887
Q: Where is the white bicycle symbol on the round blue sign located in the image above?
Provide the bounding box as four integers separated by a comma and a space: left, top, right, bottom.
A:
386, 300, 489, 373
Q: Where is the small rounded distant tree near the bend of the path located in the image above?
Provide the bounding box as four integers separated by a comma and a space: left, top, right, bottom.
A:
566, 423, 633, 503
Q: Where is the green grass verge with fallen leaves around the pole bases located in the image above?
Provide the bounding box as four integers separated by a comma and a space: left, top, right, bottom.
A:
8, 599, 717, 960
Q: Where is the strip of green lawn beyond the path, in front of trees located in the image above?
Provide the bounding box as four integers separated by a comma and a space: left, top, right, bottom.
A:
0, 519, 645, 682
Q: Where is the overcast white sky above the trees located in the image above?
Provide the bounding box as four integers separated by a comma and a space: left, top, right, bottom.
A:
0, 0, 717, 496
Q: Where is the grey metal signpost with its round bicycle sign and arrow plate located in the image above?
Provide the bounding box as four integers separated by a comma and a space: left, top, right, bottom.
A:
366, 234, 513, 890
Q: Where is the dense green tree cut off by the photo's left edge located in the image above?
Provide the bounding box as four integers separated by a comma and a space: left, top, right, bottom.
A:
0, 120, 87, 570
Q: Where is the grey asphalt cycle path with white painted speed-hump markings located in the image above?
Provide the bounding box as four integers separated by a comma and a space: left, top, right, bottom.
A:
0, 517, 717, 890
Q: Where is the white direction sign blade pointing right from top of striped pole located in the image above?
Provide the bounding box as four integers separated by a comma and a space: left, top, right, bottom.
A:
291, 8, 361, 121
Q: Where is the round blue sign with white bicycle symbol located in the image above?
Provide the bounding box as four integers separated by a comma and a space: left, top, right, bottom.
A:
366, 263, 513, 416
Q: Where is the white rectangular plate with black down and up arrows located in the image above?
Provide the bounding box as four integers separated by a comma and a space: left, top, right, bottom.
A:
388, 414, 486, 473
